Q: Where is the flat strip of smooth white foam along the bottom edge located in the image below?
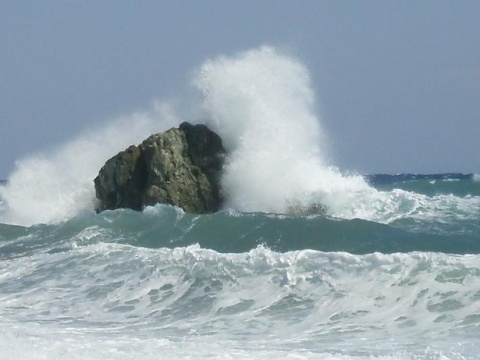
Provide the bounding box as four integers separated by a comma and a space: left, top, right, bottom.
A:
0, 325, 454, 360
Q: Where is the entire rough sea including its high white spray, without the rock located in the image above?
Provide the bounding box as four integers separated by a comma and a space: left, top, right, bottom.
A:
0, 47, 480, 360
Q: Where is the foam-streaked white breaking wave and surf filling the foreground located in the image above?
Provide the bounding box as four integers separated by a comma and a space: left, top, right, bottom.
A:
0, 243, 480, 360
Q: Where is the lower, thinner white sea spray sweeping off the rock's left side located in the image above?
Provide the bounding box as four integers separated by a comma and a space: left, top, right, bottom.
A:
0, 103, 178, 226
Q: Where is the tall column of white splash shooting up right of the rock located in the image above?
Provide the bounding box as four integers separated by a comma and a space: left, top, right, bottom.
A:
194, 47, 373, 213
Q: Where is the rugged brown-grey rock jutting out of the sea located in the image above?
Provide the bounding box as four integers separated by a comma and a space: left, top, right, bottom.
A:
94, 123, 226, 213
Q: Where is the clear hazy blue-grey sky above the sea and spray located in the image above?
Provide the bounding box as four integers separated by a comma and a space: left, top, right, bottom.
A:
0, 0, 480, 179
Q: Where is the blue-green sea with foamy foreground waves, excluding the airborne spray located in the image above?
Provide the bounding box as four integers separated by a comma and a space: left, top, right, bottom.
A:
0, 174, 480, 359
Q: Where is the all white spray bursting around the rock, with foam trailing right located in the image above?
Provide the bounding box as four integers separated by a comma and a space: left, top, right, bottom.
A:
0, 47, 478, 225
